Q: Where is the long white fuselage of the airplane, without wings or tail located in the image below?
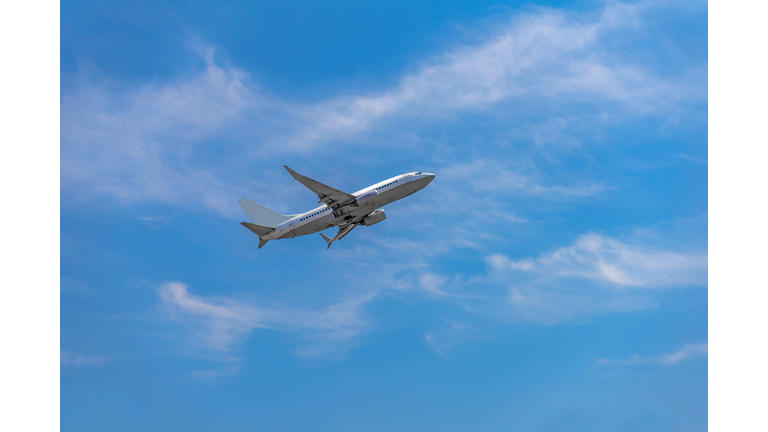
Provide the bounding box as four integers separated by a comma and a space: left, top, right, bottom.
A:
261, 172, 435, 240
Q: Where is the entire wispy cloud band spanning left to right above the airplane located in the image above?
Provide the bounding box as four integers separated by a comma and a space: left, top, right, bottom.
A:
61, 1, 706, 216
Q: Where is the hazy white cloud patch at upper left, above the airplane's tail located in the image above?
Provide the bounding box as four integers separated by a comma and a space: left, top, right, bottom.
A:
61, 51, 263, 214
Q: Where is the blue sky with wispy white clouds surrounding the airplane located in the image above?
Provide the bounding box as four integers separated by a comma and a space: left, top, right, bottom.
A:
61, 1, 708, 431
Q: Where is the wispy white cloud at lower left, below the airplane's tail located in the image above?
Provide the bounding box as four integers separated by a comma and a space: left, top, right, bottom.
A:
160, 282, 376, 357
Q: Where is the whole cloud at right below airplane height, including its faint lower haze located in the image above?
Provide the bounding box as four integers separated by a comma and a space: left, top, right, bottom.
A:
464, 218, 708, 324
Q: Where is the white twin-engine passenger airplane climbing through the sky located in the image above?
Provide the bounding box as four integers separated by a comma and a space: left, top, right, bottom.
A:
238, 165, 435, 249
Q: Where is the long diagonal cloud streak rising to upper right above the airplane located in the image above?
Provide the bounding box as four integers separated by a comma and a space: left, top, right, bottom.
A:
284, 1, 706, 149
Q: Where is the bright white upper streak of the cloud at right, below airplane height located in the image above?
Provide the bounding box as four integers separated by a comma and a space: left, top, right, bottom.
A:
486, 233, 708, 288
